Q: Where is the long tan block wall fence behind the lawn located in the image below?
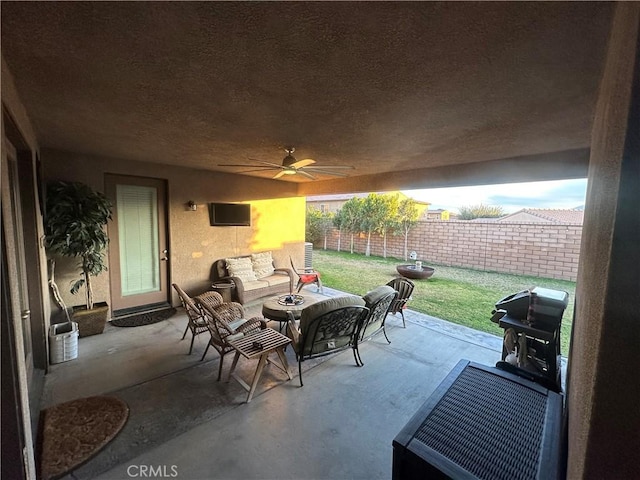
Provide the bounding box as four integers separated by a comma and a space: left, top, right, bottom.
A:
314, 220, 582, 281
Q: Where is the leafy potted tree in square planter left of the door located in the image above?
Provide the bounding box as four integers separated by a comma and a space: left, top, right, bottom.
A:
44, 181, 112, 337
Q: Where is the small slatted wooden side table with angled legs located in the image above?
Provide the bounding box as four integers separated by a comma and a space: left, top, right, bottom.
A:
227, 328, 293, 403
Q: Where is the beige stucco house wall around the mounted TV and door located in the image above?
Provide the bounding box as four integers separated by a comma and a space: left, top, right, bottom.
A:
42, 150, 305, 306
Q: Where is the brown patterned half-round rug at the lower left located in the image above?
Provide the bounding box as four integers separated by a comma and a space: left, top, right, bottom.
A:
39, 396, 129, 480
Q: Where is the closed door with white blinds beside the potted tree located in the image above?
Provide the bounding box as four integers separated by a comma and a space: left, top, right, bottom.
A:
107, 175, 169, 315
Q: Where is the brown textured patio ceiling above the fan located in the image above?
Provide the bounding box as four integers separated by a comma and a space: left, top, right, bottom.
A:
1, 1, 612, 190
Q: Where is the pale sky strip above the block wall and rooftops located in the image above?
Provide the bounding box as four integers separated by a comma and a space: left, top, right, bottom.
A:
402, 178, 587, 213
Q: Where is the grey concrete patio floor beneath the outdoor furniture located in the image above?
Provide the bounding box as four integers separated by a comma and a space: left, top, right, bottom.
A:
42, 287, 508, 480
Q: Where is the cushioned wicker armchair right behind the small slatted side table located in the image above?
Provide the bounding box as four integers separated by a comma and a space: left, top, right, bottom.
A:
194, 292, 267, 381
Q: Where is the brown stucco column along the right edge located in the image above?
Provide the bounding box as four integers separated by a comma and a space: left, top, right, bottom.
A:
567, 2, 640, 479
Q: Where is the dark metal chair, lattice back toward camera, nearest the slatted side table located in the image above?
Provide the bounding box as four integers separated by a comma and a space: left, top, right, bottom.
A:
287, 296, 369, 387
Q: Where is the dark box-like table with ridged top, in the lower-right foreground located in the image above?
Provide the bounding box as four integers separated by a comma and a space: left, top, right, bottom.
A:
393, 360, 562, 480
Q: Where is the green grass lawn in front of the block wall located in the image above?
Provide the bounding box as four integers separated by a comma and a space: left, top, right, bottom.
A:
313, 250, 576, 356
